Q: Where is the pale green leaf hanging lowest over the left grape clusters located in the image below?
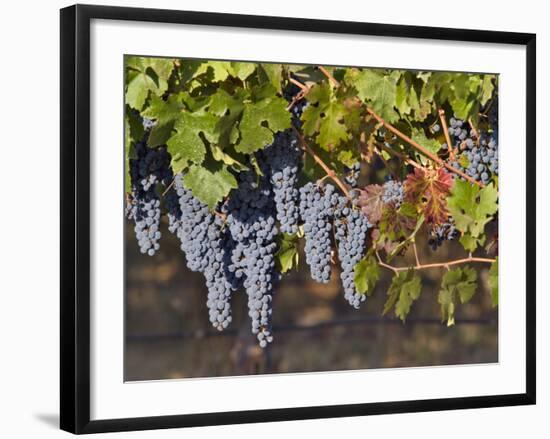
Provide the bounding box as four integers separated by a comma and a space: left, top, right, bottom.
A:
183, 161, 237, 209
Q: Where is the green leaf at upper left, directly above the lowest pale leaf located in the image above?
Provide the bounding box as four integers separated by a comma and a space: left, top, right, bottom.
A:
166, 112, 218, 174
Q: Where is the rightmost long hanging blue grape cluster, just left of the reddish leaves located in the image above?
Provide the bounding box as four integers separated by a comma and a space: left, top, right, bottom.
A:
334, 196, 371, 309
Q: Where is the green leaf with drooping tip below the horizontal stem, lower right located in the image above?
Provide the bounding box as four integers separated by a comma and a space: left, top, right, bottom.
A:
437, 267, 477, 326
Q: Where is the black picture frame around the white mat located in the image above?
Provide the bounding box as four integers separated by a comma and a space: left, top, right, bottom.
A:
60, 5, 536, 434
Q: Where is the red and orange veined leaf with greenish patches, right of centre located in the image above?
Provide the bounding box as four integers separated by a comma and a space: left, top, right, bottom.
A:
405, 168, 453, 224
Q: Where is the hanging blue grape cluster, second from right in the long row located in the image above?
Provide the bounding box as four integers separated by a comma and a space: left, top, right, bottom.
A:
300, 182, 338, 283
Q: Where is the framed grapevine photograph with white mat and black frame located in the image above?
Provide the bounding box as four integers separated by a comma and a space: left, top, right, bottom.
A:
61, 5, 536, 433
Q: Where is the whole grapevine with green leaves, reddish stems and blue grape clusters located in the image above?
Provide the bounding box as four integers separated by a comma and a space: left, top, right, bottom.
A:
125, 56, 499, 348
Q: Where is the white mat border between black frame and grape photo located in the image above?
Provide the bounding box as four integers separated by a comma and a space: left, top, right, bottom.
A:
91, 14, 525, 419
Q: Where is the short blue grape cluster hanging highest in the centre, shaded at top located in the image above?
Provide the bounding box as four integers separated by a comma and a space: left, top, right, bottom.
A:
262, 130, 302, 234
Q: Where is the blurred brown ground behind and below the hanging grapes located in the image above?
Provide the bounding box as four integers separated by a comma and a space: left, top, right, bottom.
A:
124, 215, 498, 381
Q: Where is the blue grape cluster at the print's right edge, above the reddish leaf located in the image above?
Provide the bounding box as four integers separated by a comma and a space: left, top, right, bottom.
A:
449, 117, 498, 184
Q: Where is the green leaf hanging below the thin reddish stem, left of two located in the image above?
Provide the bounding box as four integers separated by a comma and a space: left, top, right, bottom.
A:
382, 269, 422, 322
